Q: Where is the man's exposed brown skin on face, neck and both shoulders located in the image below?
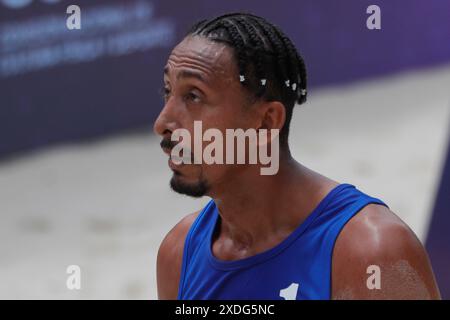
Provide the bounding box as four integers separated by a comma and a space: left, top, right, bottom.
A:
154, 36, 440, 299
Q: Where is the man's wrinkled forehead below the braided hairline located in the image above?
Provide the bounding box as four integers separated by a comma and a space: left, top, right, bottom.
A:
166, 36, 237, 80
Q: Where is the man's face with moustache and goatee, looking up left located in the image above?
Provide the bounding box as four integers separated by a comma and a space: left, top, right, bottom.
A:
154, 36, 257, 196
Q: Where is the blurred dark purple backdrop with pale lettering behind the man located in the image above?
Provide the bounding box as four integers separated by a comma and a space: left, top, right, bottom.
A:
0, 0, 450, 298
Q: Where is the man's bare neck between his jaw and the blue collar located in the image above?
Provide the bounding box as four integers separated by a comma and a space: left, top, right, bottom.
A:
207, 153, 335, 250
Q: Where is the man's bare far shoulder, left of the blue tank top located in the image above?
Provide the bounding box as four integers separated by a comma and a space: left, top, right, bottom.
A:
156, 210, 200, 299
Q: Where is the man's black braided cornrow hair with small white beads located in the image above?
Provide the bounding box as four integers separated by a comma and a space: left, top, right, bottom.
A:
187, 13, 306, 144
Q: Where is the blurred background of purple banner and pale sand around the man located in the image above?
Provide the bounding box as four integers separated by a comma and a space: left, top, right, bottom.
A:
0, 0, 450, 299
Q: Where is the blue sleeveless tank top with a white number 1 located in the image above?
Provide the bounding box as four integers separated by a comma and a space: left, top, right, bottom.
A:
178, 184, 387, 300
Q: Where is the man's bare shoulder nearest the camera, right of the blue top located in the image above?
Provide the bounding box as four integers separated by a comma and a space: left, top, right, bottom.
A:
332, 204, 440, 299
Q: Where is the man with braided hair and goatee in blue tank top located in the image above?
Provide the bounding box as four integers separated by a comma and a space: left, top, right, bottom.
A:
155, 13, 440, 299
